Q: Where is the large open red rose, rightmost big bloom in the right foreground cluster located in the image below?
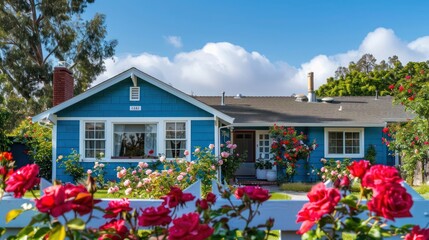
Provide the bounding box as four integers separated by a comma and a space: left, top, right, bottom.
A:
368, 183, 413, 220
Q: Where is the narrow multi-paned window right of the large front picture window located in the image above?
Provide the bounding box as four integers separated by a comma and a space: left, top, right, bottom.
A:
165, 122, 186, 158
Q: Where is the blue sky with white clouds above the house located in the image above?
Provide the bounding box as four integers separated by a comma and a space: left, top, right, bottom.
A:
84, 0, 429, 95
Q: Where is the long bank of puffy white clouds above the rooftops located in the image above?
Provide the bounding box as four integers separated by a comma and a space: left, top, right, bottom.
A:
96, 28, 429, 96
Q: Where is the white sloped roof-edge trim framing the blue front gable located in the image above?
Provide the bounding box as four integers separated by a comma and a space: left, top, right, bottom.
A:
33, 67, 234, 123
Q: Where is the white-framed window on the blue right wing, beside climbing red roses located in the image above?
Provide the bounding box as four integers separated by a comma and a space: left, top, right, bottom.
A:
325, 128, 364, 157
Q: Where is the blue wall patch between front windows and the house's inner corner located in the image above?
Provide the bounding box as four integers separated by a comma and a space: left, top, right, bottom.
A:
191, 120, 215, 160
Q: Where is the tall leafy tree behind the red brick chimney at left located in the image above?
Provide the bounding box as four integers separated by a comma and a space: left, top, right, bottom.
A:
0, 0, 117, 130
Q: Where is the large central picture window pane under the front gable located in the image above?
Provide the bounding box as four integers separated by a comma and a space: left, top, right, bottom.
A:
112, 124, 157, 158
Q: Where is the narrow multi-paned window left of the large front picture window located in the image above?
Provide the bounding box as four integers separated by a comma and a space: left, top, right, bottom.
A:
84, 122, 106, 158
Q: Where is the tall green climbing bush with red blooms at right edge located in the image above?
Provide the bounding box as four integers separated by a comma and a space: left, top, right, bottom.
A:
383, 62, 429, 183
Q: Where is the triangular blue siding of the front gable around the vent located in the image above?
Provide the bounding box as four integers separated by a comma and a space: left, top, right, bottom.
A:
57, 78, 213, 117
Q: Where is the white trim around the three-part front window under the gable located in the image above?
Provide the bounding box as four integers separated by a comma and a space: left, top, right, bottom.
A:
79, 118, 190, 163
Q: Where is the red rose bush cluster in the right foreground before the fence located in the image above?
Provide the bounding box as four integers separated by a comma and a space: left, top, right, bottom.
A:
297, 160, 427, 239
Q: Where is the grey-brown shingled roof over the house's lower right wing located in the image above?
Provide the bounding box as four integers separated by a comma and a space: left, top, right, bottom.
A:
195, 96, 413, 127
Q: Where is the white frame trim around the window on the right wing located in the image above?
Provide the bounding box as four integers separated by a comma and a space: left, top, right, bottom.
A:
324, 128, 365, 158
